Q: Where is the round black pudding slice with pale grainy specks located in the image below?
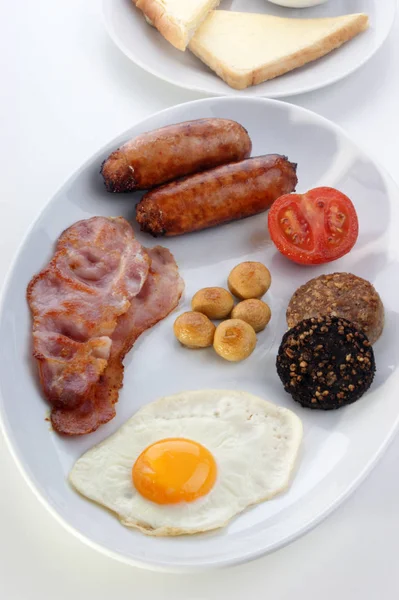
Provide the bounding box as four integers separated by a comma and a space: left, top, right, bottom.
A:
277, 317, 375, 410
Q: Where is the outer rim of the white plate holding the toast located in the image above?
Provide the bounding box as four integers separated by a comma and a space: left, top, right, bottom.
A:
101, 0, 399, 100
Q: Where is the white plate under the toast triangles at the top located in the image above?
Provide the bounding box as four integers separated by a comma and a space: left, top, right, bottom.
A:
103, 0, 397, 98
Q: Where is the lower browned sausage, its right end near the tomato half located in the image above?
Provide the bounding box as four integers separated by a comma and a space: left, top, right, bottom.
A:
136, 154, 298, 236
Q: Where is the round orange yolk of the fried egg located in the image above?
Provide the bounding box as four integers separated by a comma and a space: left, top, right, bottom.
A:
132, 438, 217, 504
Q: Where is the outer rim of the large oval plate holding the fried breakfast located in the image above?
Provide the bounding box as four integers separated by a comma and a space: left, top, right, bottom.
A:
0, 96, 399, 573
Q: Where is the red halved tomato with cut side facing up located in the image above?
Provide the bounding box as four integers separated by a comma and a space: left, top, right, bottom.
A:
269, 187, 359, 265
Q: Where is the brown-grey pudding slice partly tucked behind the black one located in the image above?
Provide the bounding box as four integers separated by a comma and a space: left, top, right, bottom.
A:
287, 273, 384, 344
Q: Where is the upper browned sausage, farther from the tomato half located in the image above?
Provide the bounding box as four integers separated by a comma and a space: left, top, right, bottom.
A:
101, 119, 252, 192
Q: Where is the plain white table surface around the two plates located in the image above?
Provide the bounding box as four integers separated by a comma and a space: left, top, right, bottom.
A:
0, 0, 399, 600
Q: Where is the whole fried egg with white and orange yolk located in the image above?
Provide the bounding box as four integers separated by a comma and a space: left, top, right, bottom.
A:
69, 390, 302, 536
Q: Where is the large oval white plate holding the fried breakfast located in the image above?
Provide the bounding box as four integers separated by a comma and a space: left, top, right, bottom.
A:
0, 98, 399, 570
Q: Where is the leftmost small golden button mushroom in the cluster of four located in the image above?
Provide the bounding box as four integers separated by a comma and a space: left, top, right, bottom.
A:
173, 311, 216, 348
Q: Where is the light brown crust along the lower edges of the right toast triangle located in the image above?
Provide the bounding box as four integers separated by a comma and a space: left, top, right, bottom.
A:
189, 14, 369, 90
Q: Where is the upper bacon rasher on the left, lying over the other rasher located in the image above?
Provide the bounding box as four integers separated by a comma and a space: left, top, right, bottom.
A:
27, 217, 150, 408
